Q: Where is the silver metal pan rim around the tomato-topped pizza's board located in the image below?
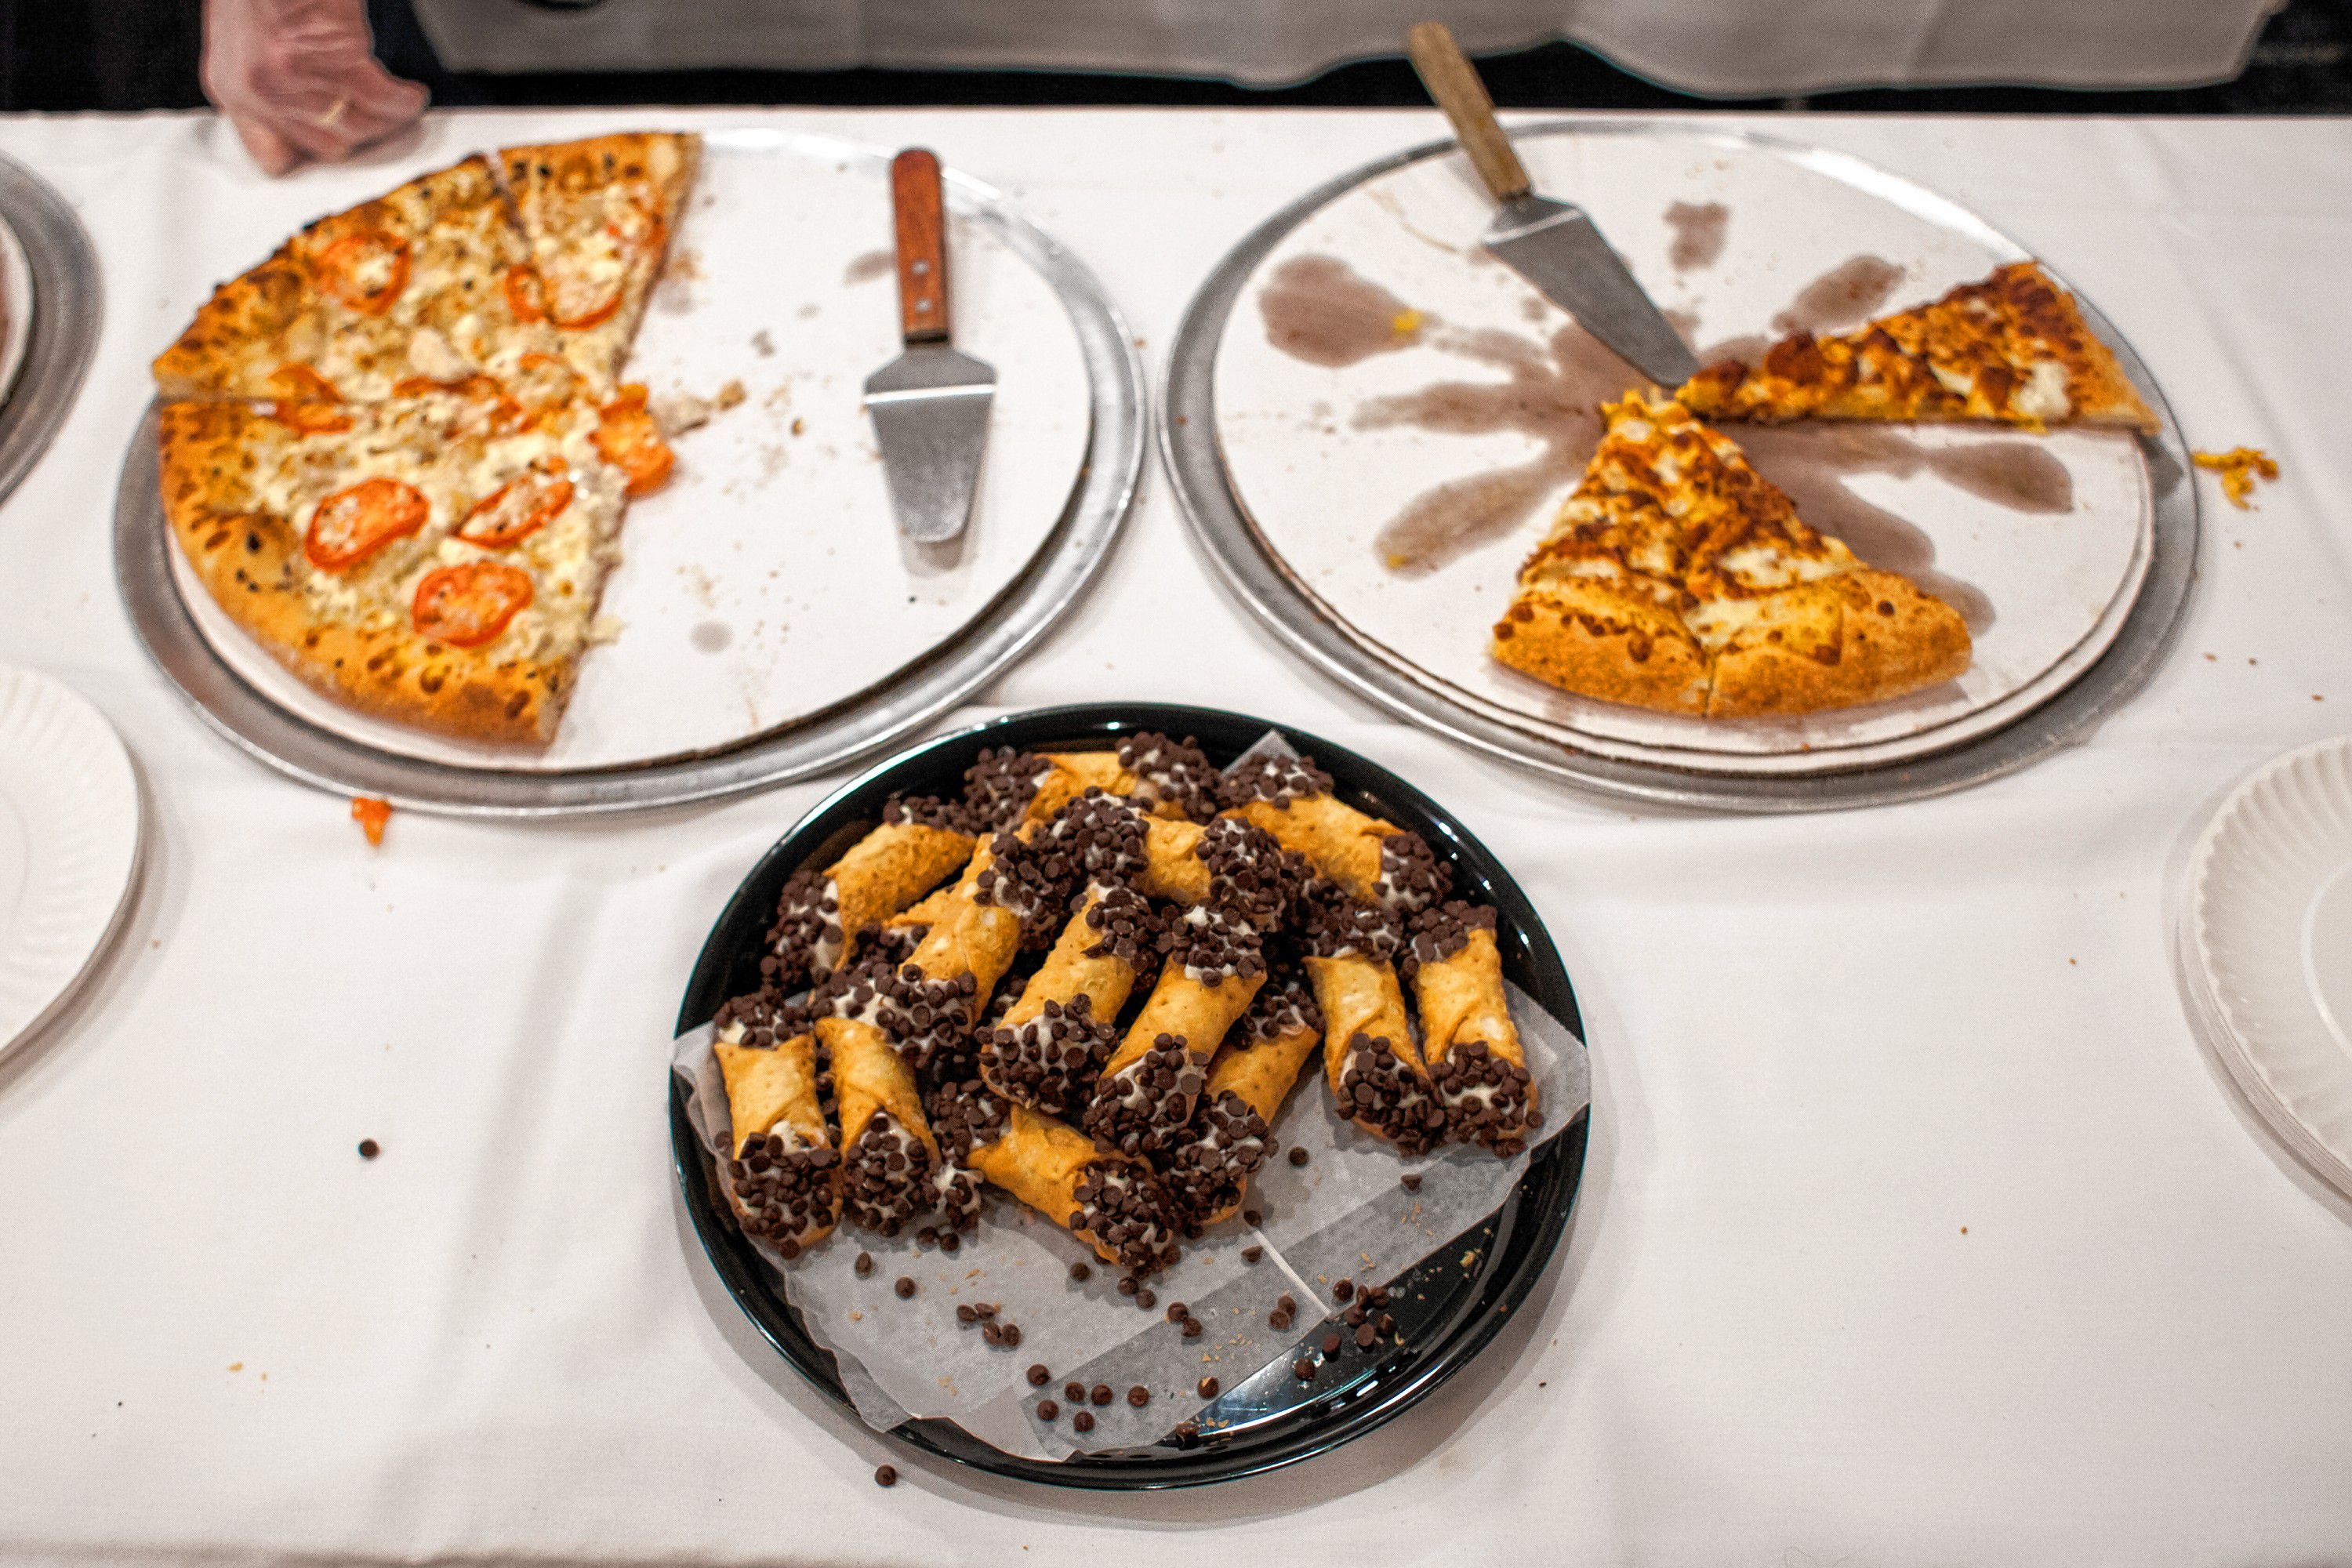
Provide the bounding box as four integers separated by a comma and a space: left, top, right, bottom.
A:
115, 143, 1150, 818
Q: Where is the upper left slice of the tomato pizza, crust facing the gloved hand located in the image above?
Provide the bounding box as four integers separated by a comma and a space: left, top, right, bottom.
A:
155, 155, 562, 402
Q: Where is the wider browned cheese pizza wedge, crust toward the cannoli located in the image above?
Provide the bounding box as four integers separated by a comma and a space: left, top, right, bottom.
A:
1491, 393, 1969, 717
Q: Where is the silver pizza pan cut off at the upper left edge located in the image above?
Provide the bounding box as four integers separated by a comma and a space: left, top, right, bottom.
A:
0, 158, 101, 510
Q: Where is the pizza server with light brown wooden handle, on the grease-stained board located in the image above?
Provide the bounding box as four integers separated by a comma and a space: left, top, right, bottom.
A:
1406, 21, 1698, 388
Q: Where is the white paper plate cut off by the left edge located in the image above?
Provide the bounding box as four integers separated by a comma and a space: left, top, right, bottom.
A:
0, 666, 139, 1051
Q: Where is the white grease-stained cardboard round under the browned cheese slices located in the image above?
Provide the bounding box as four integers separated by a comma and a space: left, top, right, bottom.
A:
1216, 129, 2154, 774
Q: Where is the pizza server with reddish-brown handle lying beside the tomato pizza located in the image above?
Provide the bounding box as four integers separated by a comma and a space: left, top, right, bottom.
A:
866, 148, 997, 546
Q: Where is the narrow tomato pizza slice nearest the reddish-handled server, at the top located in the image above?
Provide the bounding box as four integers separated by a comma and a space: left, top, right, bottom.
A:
499, 132, 701, 386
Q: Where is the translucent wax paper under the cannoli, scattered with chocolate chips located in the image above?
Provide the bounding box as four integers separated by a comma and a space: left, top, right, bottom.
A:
670, 739, 1590, 1460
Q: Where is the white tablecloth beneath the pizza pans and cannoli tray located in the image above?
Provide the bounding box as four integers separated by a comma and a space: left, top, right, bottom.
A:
0, 113, 2352, 1568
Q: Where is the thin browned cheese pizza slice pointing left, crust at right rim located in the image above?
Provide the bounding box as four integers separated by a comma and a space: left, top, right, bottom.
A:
1675, 261, 2157, 430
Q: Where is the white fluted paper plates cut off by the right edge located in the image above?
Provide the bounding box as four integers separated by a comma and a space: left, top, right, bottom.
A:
2178, 736, 2352, 1194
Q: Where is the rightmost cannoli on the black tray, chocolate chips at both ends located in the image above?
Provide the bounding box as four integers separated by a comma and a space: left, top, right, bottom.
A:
1402, 902, 1543, 1154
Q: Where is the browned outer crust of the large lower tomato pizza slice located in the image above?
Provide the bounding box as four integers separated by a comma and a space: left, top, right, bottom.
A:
160, 402, 572, 746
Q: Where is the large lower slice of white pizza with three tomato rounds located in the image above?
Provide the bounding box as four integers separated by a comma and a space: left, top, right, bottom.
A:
160, 376, 644, 746
